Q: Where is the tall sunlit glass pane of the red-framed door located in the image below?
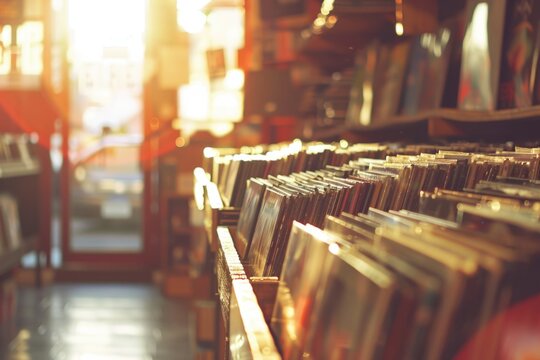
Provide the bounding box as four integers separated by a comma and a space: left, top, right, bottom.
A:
63, 0, 146, 264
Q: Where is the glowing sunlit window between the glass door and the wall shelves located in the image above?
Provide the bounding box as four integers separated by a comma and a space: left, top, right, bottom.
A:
176, 0, 245, 137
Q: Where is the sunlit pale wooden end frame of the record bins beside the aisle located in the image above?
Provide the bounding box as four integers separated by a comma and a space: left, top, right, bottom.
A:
195, 171, 281, 360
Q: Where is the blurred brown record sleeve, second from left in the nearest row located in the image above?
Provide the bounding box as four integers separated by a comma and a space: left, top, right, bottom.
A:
306, 243, 396, 359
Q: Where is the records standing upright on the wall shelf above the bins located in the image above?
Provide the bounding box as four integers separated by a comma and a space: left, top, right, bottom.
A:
303, 0, 540, 131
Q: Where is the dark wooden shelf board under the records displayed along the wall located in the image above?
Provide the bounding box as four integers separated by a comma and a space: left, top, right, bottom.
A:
312, 106, 540, 141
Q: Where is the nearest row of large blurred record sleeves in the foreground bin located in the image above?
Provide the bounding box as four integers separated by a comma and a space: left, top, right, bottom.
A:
270, 203, 540, 359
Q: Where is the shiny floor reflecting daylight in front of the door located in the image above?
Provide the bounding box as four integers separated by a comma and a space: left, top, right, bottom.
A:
0, 284, 195, 360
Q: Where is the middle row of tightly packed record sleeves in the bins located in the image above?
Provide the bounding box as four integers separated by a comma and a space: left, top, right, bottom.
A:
229, 146, 539, 276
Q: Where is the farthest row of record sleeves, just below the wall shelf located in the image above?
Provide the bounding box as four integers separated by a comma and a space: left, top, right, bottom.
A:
205, 141, 539, 207
